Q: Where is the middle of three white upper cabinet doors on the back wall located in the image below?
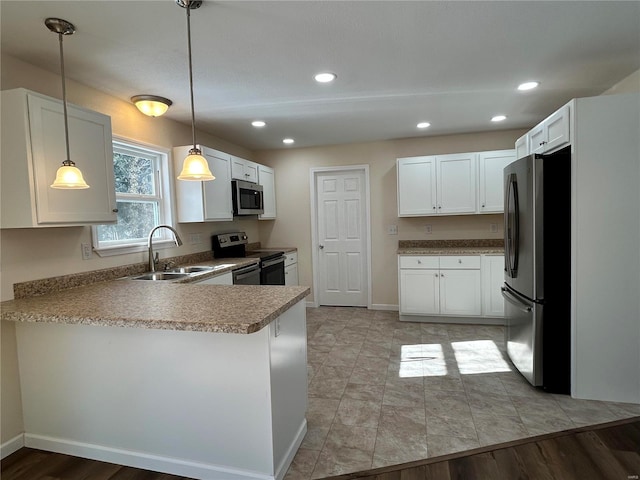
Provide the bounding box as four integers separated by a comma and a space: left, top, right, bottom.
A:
436, 153, 477, 214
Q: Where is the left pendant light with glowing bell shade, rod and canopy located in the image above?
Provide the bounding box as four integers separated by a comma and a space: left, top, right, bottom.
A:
44, 18, 89, 190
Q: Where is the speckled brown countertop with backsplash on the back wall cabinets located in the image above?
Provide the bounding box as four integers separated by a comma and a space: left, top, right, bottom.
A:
397, 239, 504, 255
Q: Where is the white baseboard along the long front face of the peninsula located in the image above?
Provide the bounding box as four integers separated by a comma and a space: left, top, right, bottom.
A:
24, 434, 272, 480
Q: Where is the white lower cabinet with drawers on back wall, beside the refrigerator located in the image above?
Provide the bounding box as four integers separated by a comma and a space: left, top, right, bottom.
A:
398, 255, 504, 321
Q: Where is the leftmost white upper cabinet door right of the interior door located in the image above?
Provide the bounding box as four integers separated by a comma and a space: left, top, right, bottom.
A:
397, 157, 436, 217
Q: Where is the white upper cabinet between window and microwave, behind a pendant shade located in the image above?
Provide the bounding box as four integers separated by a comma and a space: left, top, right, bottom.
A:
173, 145, 233, 223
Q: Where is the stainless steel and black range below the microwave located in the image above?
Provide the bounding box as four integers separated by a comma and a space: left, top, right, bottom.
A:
211, 232, 286, 285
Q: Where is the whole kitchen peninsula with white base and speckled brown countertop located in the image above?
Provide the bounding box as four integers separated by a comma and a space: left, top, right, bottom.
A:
2, 280, 309, 480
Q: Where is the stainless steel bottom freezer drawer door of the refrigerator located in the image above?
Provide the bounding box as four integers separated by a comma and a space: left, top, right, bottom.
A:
502, 285, 543, 387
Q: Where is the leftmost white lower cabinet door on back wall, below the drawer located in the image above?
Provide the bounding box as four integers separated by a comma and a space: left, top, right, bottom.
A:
400, 269, 440, 315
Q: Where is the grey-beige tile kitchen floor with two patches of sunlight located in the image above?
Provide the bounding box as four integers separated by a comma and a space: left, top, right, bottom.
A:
285, 307, 640, 480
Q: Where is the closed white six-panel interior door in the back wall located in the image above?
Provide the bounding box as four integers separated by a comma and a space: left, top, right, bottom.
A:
316, 170, 369, 307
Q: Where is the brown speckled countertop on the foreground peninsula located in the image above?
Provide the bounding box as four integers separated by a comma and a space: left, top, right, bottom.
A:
1, 277, 310, 334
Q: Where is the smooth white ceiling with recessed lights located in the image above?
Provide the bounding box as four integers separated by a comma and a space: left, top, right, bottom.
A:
0, 0, 640, 150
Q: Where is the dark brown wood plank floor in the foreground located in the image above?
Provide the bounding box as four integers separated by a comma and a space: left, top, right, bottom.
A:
0, 417, 640, 480
